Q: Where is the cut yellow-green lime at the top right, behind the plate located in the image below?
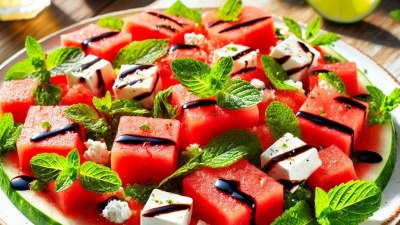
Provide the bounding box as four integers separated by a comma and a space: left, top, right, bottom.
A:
306, 0, 380, 23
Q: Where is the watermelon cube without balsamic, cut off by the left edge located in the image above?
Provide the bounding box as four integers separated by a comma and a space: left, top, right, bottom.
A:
0, 79, 37, 123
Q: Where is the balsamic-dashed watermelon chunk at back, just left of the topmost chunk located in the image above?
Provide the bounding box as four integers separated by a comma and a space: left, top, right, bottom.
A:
122, 11, 196, 44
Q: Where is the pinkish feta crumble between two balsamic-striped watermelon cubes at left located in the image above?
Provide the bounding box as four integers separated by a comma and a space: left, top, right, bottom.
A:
83, 139, 111, 165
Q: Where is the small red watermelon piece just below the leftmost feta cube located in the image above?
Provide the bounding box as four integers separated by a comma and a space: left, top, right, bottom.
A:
60, 84, 94, 106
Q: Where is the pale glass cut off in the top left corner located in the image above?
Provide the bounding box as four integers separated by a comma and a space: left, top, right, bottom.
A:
0, 0, 51, 21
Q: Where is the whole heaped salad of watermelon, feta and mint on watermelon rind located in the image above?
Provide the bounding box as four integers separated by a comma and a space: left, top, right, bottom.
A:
0, 0, 400, 225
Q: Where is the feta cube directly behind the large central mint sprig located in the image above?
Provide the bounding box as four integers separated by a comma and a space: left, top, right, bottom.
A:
213, 44, 258, 75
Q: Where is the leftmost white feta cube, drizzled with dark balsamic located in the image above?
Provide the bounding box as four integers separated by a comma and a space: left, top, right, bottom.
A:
66, 55, 115, 96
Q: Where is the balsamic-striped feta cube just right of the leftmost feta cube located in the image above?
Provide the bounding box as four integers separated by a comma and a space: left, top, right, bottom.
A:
113, 65, 162, 108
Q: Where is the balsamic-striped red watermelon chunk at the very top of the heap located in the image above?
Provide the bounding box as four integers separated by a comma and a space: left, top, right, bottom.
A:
203, 6, 277, 54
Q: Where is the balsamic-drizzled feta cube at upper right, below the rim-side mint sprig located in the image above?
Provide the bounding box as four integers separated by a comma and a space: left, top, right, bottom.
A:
270, 35, 321, 81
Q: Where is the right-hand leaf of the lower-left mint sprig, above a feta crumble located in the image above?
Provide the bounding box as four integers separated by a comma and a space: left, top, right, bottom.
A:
79, 162, 122, 194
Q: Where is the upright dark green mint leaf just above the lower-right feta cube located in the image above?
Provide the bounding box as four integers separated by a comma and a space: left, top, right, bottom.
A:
265, 101, 301, 140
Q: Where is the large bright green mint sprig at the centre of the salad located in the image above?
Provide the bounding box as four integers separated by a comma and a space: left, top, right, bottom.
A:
171, 57, 261, 109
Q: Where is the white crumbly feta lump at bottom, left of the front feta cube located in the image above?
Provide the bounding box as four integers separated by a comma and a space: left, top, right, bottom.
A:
102, 199, 132, 223
